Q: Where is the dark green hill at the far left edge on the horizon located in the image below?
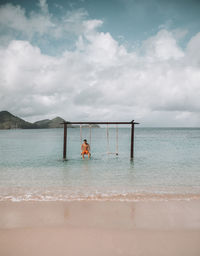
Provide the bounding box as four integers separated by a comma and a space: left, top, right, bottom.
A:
0, 111, 37, 130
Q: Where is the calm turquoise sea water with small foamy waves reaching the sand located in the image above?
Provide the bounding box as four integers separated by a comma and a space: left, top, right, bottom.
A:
0, 128, 200, 200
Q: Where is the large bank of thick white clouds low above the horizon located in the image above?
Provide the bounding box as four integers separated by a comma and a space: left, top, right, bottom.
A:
0, 1, 200, 126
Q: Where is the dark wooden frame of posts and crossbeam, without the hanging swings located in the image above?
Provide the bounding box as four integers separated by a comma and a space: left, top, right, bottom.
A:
62, 120, 139, 160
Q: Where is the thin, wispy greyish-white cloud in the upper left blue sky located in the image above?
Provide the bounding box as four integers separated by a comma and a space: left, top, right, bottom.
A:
0, 0, 91, 43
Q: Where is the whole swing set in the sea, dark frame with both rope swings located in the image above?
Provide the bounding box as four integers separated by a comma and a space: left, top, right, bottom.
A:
62, 120, 139, 160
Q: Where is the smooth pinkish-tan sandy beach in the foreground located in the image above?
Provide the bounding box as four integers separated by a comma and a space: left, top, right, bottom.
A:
0, 200, 200, 256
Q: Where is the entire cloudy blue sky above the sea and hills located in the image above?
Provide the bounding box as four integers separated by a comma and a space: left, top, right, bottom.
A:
0, 0, 200, 126
